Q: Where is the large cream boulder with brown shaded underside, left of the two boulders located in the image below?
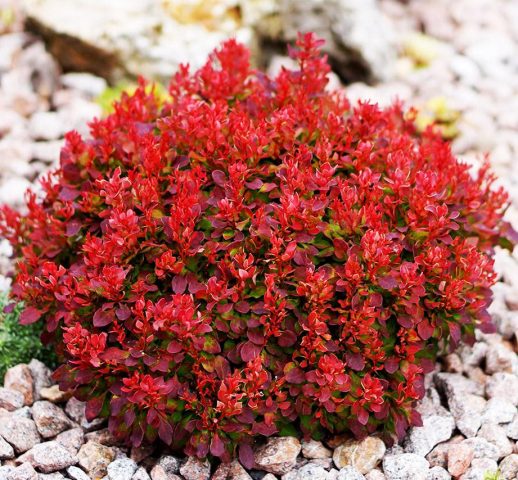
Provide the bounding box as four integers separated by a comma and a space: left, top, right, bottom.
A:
22, 0, 252, 82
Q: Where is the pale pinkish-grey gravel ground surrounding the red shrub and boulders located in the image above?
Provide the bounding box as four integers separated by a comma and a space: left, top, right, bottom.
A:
0, 0, 518, 480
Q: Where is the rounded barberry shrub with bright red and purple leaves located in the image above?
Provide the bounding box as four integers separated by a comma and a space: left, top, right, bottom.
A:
1, 34, 513, 465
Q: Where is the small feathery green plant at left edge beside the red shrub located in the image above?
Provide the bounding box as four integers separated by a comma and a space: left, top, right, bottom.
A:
0, 294, 57, 378
